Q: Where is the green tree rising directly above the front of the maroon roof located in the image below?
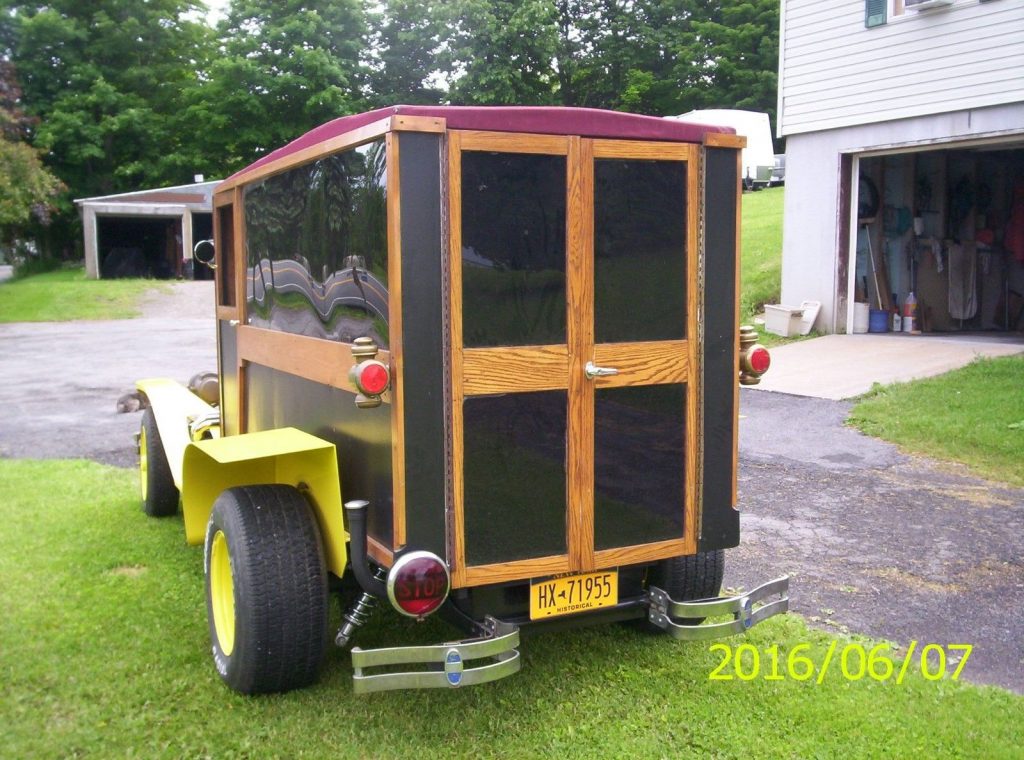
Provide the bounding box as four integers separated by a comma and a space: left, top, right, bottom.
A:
187, 0, 367, 171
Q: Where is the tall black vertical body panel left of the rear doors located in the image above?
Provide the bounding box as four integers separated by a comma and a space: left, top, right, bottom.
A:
397, 132, 451, 560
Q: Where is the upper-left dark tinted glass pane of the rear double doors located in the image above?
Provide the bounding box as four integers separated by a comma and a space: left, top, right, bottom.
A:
462, 152, 565, 346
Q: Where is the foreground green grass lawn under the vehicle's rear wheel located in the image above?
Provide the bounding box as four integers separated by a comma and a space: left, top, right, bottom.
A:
0, 460, 1024, 758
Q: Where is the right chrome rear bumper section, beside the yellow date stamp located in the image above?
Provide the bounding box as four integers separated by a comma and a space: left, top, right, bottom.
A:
647, 576, 790, 640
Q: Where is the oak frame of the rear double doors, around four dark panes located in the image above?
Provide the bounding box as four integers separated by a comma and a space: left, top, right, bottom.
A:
447, 130, 700, 588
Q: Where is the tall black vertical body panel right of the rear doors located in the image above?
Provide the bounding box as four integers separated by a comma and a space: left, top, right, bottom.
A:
697, 147, 739, 551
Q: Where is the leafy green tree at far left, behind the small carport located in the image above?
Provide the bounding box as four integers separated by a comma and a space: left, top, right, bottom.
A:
4, 0, 213, 255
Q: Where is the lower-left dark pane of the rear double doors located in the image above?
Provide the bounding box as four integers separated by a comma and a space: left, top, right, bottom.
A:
463, 390, 566, 565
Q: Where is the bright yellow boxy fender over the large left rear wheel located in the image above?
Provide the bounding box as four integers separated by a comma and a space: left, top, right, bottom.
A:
181, 427, 348, 577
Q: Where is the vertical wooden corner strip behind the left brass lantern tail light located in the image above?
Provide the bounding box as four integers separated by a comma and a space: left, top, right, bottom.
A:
385, 132, 406, 550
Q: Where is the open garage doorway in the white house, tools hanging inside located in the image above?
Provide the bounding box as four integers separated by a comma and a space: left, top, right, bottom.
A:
849, 144, 1024, 333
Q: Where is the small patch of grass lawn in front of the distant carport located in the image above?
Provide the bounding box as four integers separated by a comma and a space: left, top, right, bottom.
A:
0, 267, 167, 323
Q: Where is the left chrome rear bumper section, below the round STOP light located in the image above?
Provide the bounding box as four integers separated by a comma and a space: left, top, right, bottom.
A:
352, 621, 520, 694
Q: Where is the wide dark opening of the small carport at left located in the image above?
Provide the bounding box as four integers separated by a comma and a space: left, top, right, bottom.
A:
96, 216, 183, 280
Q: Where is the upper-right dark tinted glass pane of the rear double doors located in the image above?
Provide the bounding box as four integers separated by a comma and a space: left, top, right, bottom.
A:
594, 159, 686, 343
